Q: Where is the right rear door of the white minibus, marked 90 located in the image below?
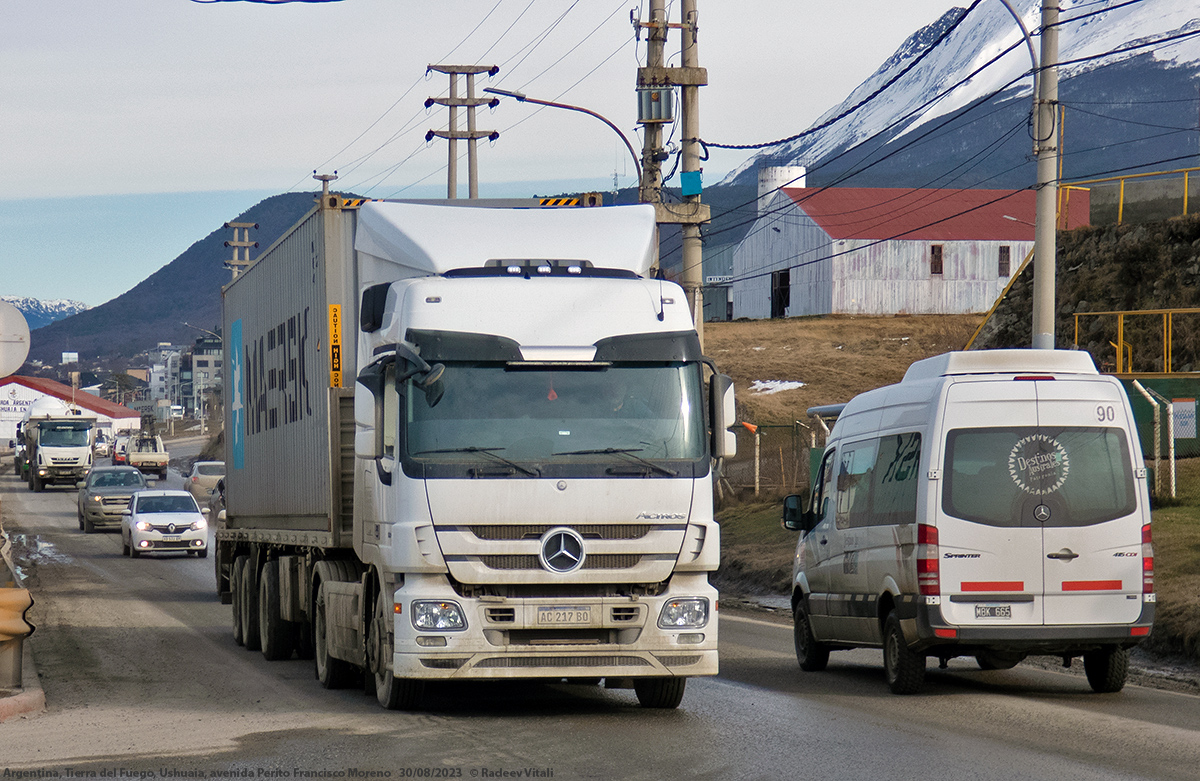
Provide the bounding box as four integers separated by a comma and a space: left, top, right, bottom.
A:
1036, 378, 1150, 625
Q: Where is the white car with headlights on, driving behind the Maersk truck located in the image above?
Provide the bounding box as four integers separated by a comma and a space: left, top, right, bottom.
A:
121, 491, 209, 559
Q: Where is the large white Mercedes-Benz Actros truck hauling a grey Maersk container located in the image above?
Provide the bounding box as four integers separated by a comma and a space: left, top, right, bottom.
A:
215, 194, 733, 709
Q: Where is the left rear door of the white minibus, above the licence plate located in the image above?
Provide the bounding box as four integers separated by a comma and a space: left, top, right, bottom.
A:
937, 379, 1044, 626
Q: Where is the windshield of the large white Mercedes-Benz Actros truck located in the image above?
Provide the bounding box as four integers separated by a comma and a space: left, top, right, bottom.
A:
403, 362, 707, 475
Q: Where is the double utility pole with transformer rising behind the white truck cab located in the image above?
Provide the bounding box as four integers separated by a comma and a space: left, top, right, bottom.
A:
635, 0, 710, 348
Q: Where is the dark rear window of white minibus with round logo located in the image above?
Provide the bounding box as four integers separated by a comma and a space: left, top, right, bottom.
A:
942, 426, 1136, 527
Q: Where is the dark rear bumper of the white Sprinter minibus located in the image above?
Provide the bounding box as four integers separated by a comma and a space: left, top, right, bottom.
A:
912, 602, 1154, 655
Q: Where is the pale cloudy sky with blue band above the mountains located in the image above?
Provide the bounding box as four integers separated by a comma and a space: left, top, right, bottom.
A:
0, 0, 955, 305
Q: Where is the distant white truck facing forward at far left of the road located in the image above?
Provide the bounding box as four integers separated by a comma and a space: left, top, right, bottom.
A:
20, 397, 96, 491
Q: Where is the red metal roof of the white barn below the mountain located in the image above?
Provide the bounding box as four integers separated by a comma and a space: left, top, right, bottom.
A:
784, 187, 1090, 241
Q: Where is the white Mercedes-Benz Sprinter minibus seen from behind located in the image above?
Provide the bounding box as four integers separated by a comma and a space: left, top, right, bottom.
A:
784, 349, 1154, 693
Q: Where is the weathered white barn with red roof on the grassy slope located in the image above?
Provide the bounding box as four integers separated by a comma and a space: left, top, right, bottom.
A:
732, 187, 1088, 319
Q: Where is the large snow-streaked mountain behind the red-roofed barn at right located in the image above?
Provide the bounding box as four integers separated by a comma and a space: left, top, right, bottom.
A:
722, 0, 1200, 187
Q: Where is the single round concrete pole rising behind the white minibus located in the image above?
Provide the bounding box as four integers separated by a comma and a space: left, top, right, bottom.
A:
1032, 0, 1058, 350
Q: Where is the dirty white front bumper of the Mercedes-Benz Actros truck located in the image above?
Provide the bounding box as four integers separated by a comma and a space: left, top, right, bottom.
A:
392, 572, 718, 679
